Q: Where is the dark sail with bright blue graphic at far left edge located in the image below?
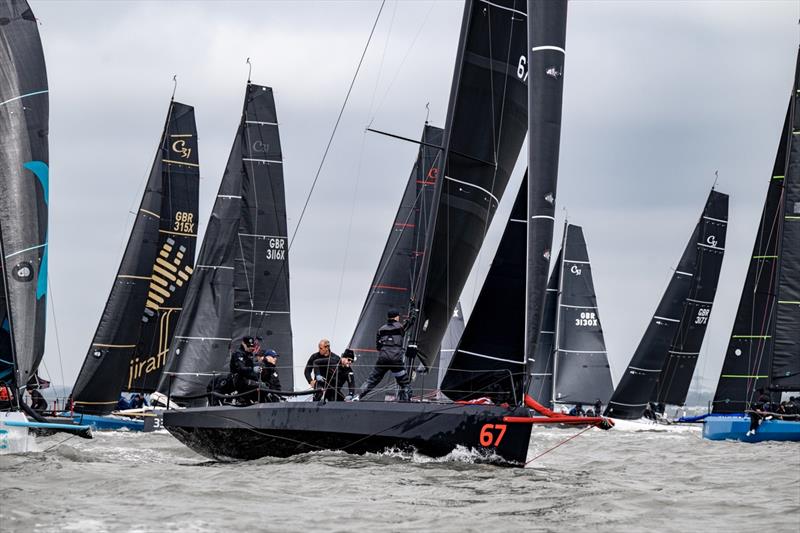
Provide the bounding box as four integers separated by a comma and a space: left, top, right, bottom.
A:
0, 0, 49, 394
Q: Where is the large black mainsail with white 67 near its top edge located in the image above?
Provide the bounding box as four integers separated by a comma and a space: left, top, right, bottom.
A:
411, 0, 527, 366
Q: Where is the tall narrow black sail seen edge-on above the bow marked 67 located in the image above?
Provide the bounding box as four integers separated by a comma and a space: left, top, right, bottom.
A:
524, 0, 567, 374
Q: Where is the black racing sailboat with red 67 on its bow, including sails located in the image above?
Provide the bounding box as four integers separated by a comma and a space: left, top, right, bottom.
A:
164, 0, 566, 465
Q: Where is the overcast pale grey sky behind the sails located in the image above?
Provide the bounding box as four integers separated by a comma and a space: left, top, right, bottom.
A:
30, 0, 800, 387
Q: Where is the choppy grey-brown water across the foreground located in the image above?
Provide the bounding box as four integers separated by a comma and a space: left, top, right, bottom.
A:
0, 422, 800, 533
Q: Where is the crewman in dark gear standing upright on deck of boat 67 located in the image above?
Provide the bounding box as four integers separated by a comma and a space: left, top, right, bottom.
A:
353, 309, 416, 402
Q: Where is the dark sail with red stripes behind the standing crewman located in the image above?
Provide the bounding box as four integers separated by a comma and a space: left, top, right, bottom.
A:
349, 124, 443, 390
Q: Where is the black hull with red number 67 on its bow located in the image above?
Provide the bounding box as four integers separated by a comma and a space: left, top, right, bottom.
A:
164, 402, 531, 466
